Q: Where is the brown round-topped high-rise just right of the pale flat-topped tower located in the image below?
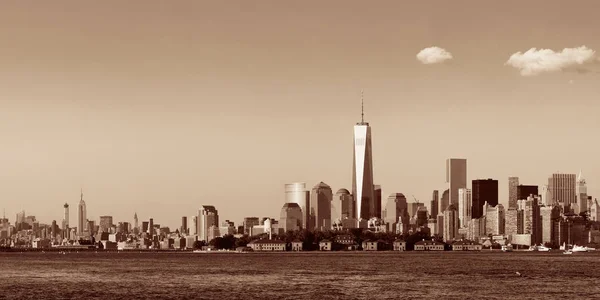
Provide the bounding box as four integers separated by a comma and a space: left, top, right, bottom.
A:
307, 182, 333, 230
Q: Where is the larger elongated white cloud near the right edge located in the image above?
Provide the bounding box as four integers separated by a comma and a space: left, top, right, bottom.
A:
505, 46, 596, 76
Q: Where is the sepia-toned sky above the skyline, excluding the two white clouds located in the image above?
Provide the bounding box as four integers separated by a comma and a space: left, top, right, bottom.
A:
0, 0, 600, 229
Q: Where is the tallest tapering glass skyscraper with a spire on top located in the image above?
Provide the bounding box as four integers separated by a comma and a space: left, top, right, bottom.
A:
352, 94, 375, 220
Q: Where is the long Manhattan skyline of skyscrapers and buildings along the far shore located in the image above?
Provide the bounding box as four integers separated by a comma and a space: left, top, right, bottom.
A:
0, 106, 600, 250
